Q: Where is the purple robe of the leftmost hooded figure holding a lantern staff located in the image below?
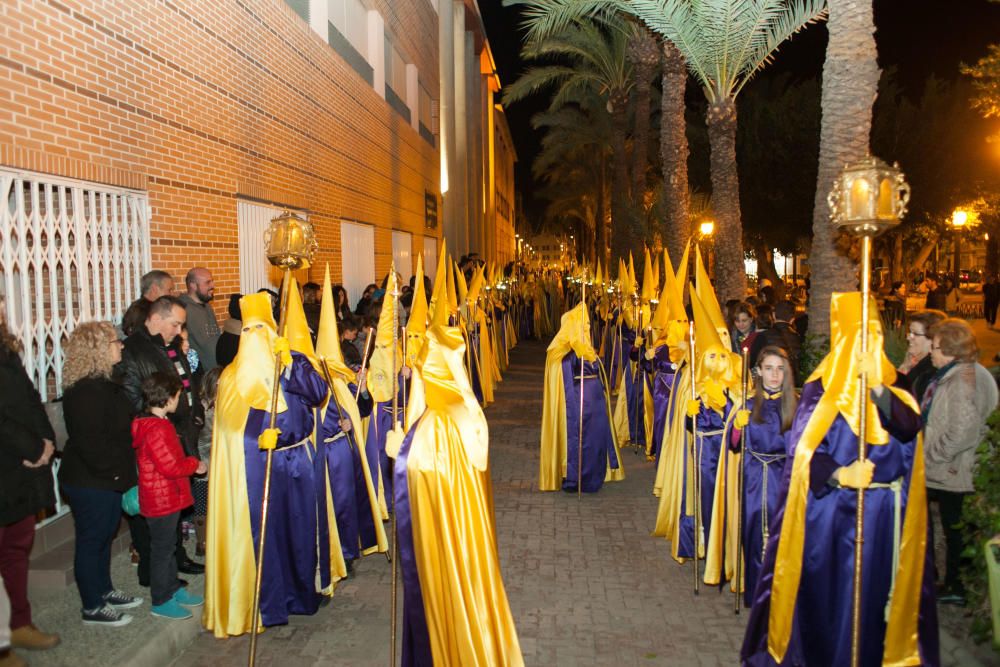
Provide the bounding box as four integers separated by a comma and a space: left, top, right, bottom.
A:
243, 352, 329, 626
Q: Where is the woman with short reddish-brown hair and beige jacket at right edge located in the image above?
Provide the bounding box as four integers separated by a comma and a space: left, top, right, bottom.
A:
920, 319, 997, 606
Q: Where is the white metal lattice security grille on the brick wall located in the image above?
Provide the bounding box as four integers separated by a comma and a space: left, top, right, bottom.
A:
0, 169, 151, 401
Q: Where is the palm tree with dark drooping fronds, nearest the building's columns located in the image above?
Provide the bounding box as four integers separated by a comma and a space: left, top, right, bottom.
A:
504, 21, 639, 264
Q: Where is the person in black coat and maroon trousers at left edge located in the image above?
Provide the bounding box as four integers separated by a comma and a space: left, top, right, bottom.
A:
0, 297, 59, 649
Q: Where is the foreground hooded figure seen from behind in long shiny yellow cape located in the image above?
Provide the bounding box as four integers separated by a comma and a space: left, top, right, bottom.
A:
390, 322, 524, 667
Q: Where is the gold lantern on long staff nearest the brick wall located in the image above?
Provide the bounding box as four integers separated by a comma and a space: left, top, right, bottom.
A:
248, 211, 319, 667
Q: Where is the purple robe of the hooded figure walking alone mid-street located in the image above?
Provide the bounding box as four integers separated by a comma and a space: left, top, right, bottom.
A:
562, 352, 619, 493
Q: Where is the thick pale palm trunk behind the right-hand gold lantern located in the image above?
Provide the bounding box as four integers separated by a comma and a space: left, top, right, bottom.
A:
809, 0, 879, 337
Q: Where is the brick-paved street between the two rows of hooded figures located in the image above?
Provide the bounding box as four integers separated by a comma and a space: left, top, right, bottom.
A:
145, 341, 982, 667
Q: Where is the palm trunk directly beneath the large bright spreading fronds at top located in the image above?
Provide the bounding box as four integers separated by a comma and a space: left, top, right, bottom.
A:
707, 97, 747, 303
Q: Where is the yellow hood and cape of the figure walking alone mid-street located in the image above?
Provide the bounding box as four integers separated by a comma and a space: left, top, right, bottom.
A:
538, 303, 625, 491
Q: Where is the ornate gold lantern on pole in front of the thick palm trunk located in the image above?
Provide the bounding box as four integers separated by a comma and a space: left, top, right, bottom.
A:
827, 155, 910, 667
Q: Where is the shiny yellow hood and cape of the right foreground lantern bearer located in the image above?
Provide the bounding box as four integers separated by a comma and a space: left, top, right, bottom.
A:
767, 292, 927, 665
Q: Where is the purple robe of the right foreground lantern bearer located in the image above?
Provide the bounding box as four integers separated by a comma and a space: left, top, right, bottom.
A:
740, 380, 940, 667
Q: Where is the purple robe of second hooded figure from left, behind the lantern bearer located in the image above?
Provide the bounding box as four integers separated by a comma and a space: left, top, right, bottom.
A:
315, 384, 378, 561
